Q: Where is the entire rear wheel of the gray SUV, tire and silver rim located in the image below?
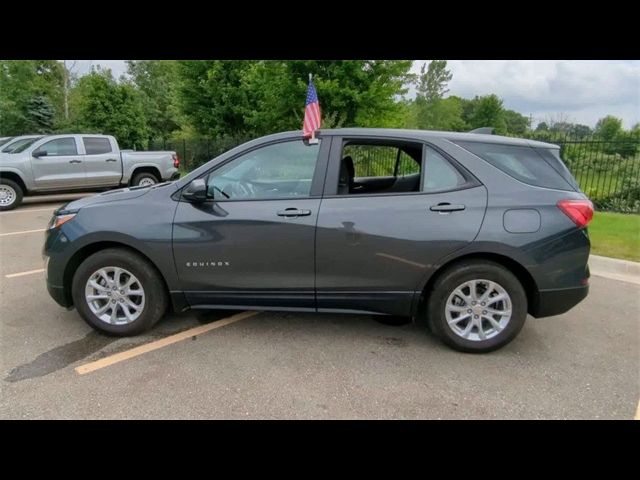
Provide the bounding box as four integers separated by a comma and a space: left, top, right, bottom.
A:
427, 260, 527, 353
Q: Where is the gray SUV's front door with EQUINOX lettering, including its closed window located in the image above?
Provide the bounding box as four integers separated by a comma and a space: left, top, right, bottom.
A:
173, 138, 331, 310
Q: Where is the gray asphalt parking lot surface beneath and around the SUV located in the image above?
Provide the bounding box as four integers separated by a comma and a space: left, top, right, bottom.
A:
0, 195, 640, 419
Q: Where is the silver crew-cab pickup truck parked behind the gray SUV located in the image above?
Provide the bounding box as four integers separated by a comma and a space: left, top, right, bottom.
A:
0, 134, 180, 211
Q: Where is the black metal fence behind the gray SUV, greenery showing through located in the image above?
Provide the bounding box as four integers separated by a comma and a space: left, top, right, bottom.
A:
149, 134, 640, 213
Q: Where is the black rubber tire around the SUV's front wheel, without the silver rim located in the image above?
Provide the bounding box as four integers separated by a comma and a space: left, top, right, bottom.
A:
71, 248, 168, 337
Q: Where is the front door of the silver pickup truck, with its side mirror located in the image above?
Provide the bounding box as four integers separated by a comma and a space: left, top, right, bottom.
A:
29, 136, 85, 190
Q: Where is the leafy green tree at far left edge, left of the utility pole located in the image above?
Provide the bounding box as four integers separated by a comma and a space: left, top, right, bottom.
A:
0, 60, 63, 135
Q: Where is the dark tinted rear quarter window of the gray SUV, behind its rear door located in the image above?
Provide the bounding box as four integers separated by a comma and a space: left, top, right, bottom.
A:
456, 142, 575, 190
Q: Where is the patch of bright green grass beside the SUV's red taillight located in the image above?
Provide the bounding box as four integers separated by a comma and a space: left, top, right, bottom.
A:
589, 212, 640, 262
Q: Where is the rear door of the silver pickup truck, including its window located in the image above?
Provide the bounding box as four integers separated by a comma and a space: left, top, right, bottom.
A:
82, 135, 122, 187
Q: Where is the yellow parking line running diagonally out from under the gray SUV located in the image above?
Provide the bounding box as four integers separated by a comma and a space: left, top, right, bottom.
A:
75, 312, 260, 375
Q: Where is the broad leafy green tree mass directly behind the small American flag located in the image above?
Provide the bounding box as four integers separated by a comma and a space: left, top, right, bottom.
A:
179, 60, 411, 136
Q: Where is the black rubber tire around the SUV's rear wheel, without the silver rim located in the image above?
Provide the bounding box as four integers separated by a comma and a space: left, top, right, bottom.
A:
427, 260, 528, 353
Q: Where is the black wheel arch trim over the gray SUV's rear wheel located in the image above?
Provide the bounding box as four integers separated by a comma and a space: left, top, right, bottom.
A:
413, 252, 539, 315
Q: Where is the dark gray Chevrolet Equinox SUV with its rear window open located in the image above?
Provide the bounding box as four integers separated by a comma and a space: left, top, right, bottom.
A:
44, 129, 593, 352
